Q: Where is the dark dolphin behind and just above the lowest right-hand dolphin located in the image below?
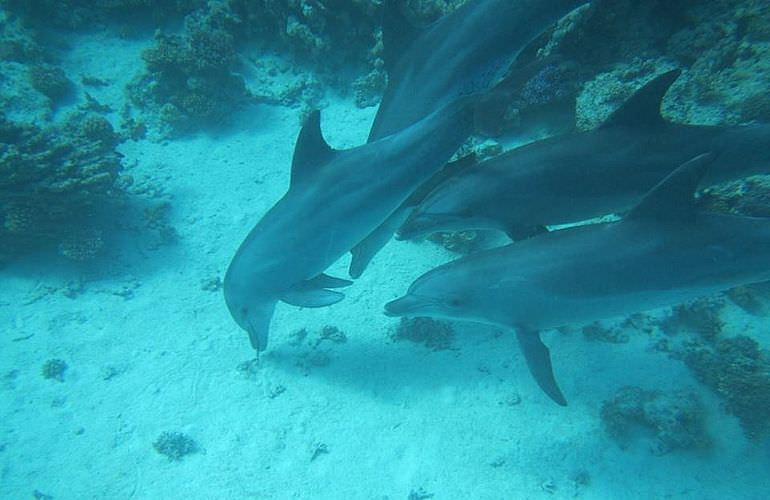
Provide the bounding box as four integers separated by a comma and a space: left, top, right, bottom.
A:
398, 71, 770, 239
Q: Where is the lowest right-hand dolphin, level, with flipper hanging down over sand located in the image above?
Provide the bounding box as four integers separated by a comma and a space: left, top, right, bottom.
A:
385, 153, 770, 405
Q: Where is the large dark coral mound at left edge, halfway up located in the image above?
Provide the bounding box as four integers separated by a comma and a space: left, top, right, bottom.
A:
0, 115, 121, 261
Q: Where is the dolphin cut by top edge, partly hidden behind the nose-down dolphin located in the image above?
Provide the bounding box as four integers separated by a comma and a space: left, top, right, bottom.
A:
350, 0, 589, 278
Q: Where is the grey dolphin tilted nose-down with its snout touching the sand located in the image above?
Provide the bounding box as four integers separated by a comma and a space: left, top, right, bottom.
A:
224, 97, 475, 351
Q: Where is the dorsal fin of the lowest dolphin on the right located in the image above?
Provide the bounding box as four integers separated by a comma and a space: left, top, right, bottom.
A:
626, 153, 717, 224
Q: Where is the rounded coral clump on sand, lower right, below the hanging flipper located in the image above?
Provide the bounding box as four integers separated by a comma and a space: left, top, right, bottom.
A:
601, 386, 711, 455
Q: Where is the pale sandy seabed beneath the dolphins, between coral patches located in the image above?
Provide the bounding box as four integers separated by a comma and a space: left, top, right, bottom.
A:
0, 30, 770, 500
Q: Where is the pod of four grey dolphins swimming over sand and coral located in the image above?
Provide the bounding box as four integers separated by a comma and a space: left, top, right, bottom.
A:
224, 0, 770, 405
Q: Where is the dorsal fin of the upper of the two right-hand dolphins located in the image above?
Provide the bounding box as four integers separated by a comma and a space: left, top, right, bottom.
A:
601, 69, 682, 128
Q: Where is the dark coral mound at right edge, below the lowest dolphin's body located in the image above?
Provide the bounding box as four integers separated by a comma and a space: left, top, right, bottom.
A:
684, 336, 770, 440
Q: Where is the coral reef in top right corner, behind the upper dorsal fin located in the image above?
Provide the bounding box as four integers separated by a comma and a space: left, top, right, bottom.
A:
546, 0, 770, 129
